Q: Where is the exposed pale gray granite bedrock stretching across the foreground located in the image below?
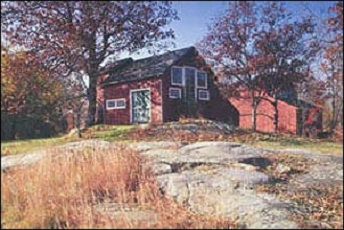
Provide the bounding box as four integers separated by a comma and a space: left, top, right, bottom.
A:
1, 139, 343, 229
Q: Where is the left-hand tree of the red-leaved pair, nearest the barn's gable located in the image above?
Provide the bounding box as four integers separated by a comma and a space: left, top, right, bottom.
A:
198, 1, 264, 131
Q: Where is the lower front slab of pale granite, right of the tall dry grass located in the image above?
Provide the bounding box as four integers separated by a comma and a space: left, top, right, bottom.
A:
158, 168, 297, 228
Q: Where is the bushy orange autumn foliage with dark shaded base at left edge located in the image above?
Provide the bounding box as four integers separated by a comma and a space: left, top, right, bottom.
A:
1, 47, 65, 139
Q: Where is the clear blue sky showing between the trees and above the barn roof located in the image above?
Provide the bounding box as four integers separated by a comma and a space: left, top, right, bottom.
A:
121, 1, 335, 59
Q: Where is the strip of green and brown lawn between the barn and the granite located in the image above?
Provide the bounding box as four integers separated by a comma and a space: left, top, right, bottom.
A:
1, 122, 343, 155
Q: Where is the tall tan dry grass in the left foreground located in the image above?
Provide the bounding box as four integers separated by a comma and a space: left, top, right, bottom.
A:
1, 146, 236, 228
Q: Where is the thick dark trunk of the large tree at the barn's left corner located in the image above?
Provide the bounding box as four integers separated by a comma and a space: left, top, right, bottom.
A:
87, 74, 97, 126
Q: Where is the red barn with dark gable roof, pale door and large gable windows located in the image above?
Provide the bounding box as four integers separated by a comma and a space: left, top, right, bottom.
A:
97, 47, 238, 125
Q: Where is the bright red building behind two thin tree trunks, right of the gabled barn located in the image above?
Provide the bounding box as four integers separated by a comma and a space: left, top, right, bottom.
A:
229, 89, 322, 136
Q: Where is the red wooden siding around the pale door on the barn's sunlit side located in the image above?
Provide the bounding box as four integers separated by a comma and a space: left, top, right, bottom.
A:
104, 78, 162, 125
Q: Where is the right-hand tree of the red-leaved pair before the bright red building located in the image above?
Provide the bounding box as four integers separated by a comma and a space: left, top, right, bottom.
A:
251, 2, 320, 133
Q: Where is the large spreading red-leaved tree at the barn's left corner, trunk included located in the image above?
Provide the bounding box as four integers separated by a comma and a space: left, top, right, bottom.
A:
1, 1, 178, 124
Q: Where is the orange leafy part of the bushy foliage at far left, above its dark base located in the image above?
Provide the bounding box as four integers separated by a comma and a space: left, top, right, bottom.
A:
1, 47, 63, 113
